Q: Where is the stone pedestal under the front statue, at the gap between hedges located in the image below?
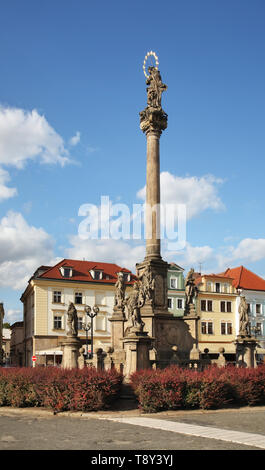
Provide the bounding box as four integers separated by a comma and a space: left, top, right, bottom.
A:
123, 332, 153, 382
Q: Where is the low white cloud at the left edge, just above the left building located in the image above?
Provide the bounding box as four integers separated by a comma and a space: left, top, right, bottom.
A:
0, 211, 55, 290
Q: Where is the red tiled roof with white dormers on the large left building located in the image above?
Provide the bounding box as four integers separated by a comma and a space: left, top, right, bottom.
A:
38, 259, 136, 284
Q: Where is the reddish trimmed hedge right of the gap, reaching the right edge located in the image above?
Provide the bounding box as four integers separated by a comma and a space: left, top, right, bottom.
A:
131, 365, 265, 413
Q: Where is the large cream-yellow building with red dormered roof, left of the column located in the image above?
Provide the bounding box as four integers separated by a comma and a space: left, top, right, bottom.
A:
20, 259, 134, 366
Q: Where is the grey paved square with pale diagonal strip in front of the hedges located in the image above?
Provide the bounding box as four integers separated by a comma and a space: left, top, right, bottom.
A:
0, 407, 265, 451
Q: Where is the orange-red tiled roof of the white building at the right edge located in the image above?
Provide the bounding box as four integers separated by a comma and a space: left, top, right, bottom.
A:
221, 266, 265, 291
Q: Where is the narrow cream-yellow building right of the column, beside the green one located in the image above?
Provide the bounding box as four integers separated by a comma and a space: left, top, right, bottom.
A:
196, 274, 238, 361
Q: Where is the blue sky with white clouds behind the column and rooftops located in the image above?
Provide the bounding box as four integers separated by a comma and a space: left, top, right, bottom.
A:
0, 0, 265, 322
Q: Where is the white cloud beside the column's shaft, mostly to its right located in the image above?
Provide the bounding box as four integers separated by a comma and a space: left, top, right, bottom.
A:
137, 171, 224, 219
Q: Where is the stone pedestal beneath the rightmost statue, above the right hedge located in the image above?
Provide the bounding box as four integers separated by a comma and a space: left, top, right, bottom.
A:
235, 335, 257, 367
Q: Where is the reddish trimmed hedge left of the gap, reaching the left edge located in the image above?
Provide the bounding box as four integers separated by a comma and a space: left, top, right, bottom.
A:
0, 367, 123, 411
